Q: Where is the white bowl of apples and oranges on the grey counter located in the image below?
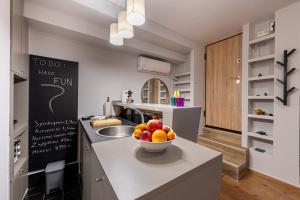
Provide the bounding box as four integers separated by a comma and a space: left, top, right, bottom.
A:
132, 119, 176, 152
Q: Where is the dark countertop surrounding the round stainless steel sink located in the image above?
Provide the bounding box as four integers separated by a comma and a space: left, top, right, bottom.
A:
79, 118, 136, 143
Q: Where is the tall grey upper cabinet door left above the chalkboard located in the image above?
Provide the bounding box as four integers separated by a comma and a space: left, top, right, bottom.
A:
11, 0, 29, 79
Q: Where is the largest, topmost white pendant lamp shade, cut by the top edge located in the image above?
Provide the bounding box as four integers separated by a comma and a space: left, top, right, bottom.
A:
127, 0, 145, 26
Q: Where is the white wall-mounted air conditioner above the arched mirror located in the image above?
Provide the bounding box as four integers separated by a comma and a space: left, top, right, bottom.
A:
138, 56, 171, 75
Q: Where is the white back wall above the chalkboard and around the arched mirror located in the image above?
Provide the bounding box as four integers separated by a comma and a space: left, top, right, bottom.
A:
29, 30, 172, 116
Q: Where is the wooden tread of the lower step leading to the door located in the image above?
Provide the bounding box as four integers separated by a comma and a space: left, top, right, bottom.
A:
198, 138, 247, 168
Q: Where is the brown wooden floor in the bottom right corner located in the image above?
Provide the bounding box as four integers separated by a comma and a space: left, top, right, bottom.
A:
219, 171, 300, 200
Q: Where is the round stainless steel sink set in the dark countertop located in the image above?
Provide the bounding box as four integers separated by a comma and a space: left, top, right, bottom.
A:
96, 125, 134, 138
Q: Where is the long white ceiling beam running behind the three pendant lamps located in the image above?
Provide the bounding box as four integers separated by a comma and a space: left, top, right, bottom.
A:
24, 2, 187, 63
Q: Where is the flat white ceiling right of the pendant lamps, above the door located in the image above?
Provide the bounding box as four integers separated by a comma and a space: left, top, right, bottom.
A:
146, 0, 299, 44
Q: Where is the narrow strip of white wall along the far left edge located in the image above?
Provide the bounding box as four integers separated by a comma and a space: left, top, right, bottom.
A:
0, 0, 10, 200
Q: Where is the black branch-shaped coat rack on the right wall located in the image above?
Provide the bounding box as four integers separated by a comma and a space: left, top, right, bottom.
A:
276, 49, 296, 106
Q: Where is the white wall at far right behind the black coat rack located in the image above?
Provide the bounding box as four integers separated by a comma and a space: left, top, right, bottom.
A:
272, 2, 300, 187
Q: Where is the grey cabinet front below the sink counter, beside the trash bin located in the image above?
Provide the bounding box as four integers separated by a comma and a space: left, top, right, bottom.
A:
81, 133, 117, 200
